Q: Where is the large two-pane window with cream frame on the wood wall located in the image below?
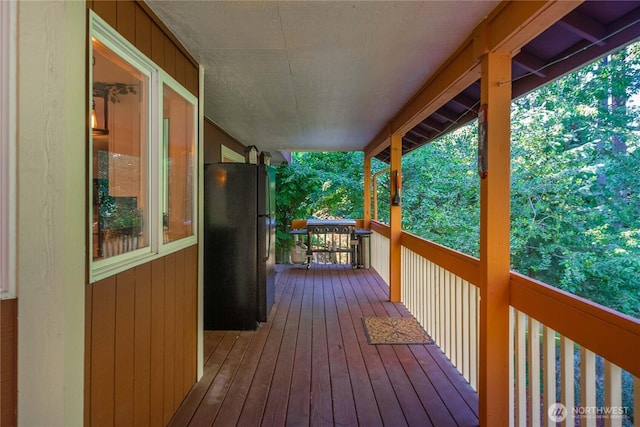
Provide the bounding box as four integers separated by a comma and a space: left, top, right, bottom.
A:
89, 12, 197, 282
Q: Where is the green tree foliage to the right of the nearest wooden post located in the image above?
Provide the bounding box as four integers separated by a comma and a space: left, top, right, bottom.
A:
512, 45, 640, 317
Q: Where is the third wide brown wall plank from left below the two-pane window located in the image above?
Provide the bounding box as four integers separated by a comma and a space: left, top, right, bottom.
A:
133, 263, 151, 426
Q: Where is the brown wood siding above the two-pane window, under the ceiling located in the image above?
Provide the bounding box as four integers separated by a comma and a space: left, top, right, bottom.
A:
87, 0, 198, 96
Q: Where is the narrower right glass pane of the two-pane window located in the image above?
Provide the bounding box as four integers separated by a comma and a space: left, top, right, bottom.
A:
162, 84, 195, 243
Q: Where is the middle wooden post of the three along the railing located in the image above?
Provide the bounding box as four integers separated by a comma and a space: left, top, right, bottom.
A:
389, 134, 402, 302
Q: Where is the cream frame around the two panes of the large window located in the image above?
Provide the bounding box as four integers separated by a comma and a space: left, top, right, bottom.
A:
86, 11, 199, 283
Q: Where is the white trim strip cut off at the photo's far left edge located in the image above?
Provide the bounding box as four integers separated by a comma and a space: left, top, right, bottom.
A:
0, 2, 16, 299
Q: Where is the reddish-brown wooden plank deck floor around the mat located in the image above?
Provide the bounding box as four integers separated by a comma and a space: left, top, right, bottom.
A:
170, 265, 478, 427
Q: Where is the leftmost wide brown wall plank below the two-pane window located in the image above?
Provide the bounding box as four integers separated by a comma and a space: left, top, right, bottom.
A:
91, 276, 116, 426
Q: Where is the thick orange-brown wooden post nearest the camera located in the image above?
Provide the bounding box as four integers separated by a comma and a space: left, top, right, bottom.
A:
478, 53, 512, 426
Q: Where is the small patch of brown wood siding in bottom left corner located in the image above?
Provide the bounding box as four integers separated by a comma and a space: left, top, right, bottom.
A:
0, 299, 18, 427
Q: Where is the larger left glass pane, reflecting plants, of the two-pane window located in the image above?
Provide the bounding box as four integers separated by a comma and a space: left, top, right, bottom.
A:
91, 39, 149, 260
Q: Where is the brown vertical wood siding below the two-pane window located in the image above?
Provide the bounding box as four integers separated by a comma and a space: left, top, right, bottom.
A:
85, 245, 198, 426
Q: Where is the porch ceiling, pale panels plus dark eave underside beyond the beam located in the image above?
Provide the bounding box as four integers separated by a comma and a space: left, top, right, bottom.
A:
147, 0, 640, 162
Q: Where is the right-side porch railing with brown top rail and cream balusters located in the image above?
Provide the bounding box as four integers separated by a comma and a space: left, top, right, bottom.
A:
372, 222, 640, 426
